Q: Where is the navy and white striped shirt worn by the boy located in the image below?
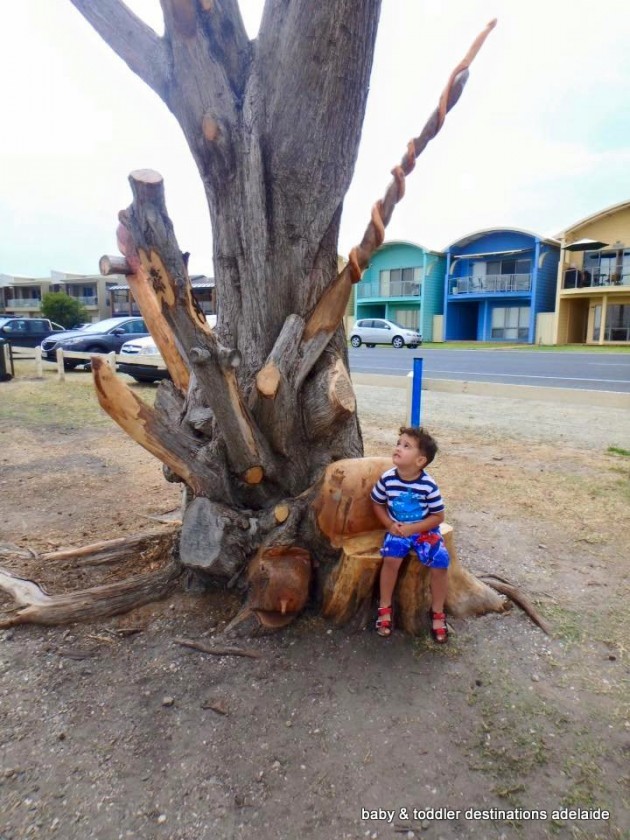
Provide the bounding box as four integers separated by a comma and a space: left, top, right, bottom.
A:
370, 467, 444, 522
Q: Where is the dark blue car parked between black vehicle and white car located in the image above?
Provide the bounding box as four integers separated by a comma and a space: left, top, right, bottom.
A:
42, 317, 149, 370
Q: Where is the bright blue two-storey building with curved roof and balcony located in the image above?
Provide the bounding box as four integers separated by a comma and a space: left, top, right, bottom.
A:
444, 228, 560, 344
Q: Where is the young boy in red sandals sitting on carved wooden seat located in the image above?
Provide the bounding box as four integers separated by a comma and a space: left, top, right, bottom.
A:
370, 426, 449, 644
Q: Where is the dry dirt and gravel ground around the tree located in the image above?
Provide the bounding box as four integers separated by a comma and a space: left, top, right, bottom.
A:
0, 373, 630, 840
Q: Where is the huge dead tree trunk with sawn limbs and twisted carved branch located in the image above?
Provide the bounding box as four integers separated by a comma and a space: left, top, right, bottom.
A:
53, 0, 508, 629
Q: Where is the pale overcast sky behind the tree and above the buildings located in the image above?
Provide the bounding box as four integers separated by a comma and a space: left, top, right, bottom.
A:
0, 0, 630, 276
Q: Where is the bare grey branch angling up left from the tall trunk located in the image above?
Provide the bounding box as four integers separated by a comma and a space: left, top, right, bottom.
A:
70, 0, 169, 101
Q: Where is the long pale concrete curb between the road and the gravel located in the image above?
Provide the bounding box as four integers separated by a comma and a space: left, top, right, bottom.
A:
351, 373, 630, 411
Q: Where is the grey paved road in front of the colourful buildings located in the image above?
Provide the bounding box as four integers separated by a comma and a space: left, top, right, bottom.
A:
349, 347, 630, 393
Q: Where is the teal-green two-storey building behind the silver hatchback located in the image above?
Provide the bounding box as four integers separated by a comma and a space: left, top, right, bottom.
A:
354, 242, 446, 341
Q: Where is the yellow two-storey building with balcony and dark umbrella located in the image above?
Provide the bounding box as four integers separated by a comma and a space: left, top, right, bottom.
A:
554, 201, 630, 345
